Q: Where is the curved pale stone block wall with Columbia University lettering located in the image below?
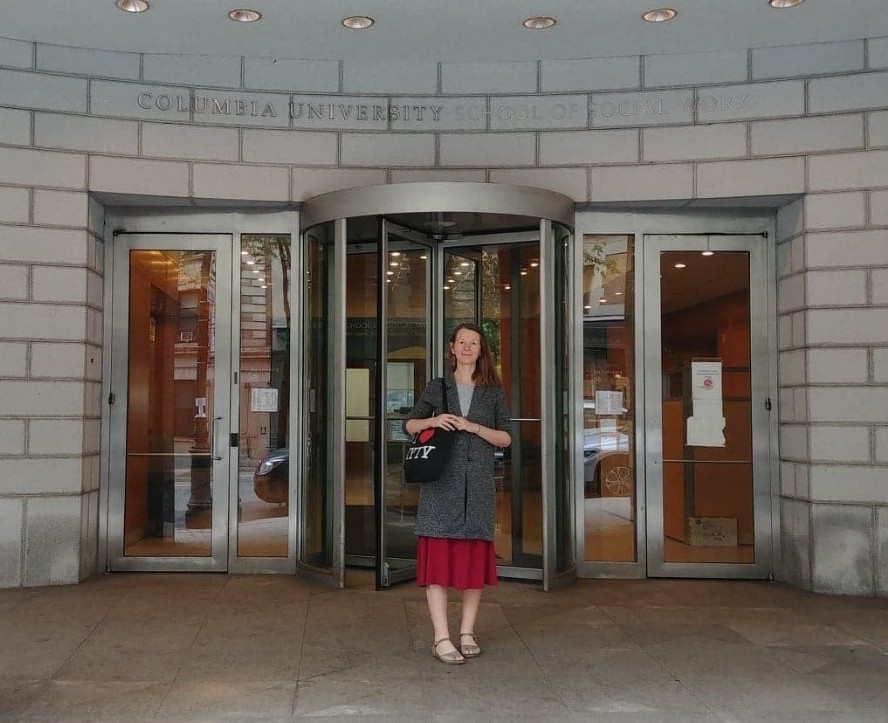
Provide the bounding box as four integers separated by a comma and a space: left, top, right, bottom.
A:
0, 32, 888, 594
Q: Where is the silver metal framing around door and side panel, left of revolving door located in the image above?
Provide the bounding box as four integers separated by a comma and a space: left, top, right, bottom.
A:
98, 207, 304, 573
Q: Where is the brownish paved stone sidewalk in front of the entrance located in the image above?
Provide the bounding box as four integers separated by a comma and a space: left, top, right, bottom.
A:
0, 574, 888, 723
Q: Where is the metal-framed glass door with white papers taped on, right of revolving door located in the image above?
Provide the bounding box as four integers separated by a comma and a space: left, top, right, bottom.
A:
644, 236, 771, 578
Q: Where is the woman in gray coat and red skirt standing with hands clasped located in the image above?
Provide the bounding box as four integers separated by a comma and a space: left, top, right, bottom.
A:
404, 324, 512, 665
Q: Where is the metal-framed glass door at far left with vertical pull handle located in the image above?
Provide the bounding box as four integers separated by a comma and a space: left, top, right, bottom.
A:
108, 234, 231, 570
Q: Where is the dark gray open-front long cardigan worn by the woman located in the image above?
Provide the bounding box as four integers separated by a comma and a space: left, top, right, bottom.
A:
405, 371, 512, 540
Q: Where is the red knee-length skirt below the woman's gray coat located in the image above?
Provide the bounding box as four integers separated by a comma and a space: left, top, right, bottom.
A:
416, 536, 496, 590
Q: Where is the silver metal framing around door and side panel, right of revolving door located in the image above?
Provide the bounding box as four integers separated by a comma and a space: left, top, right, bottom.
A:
568, 206, 781, 579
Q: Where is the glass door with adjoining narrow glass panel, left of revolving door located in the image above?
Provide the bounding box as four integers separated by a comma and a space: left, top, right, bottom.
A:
108, 230, 296, 572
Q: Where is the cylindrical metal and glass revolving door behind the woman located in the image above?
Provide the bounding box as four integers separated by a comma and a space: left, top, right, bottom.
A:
299, 183, 575, 588
